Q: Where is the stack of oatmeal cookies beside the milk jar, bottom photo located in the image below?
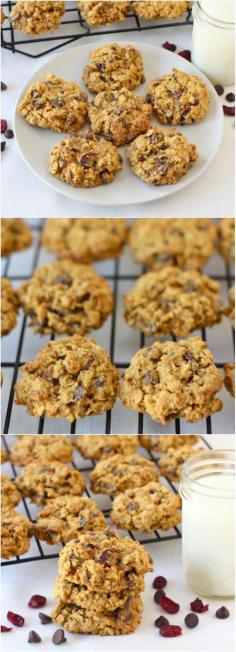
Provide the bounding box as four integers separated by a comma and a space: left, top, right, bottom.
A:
52, 527, 153, 636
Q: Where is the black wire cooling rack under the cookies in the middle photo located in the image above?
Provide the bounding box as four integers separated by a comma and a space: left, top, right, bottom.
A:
1, 220, 234, 434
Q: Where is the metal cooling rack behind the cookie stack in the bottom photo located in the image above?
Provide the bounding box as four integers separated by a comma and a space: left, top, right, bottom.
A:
1, 435, 211, 566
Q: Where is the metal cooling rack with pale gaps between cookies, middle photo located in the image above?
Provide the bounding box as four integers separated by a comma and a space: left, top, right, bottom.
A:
1, 220, 235, 435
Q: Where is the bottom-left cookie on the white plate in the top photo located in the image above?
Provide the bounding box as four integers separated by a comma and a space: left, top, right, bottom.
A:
48, 131, 122, 188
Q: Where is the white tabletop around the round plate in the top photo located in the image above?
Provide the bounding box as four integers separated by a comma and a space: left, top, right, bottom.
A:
1, 15, 234, 218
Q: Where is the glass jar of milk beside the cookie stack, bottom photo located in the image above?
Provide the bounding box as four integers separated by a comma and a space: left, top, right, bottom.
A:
180, 450, 235, 598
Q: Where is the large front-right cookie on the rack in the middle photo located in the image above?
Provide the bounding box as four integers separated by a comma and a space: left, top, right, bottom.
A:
120, 337, 223, 425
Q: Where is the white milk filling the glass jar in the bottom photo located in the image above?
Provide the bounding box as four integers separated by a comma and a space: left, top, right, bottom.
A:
182, 474, 235, 597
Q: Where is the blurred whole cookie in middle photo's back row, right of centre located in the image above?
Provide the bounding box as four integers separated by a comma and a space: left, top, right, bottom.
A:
129, 218, 216, 271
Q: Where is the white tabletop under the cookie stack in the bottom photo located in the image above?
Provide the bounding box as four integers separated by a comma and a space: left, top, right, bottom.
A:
1, 435, 234, 652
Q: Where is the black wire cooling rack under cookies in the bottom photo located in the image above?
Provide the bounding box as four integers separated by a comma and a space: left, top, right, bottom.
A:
1, 435, 211, 566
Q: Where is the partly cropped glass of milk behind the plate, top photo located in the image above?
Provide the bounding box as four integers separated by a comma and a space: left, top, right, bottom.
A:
192, 0, 235, 85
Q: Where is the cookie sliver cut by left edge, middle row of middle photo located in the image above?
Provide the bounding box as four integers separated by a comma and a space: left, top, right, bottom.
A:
1, 278, 19, 337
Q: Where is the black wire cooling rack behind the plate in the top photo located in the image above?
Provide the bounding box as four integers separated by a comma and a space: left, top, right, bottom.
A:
1, 1, 192, 59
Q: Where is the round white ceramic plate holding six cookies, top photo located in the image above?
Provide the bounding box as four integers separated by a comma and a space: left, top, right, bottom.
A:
15, 41, 223, 206
